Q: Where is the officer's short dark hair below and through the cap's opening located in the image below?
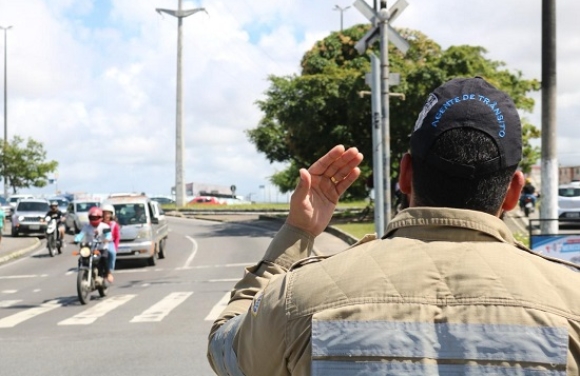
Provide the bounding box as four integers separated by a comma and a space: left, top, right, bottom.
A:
413, 128, 517, 215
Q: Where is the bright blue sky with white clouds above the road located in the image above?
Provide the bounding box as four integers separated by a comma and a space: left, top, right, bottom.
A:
0, 0, 580, 201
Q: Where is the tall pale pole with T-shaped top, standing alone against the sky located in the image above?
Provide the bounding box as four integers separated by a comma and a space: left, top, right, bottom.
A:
155, 0, 207, 208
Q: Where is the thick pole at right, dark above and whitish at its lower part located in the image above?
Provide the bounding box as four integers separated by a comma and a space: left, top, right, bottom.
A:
540, 0, 559, 234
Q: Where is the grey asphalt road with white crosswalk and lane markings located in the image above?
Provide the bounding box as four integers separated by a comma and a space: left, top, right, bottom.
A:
0, 218, 346, 376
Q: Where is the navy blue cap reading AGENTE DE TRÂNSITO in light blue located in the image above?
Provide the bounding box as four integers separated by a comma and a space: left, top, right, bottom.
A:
411, 77, 522, 179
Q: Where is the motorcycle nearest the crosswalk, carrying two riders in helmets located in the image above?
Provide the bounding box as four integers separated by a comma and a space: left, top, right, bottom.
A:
73, 235, 107, 305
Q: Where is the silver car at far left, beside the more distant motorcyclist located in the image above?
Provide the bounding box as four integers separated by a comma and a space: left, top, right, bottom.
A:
12, 198, 49, 237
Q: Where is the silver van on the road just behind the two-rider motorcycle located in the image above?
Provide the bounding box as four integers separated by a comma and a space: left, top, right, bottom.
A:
103, 194, 169, 266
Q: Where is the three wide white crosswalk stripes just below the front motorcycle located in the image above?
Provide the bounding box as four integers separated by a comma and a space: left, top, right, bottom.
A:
0, 291, 202, 333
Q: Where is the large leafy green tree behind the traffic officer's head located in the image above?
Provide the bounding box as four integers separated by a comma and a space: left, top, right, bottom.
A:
247, 25, 540, 198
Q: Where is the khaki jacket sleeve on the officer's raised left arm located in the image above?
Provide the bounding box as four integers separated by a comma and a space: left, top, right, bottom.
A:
208, 224, 314, 376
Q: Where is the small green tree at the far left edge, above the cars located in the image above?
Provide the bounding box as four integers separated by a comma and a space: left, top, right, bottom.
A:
0, 136, 58, 193
